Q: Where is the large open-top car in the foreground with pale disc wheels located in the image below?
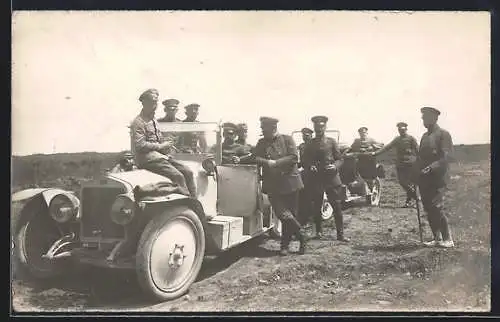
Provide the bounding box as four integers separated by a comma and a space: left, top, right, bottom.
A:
12, 122, 279, 300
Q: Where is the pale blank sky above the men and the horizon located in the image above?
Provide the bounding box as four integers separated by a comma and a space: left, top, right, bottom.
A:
12, 11, 491, 155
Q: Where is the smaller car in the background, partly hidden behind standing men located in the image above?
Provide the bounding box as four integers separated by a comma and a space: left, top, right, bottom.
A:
292, 130, 385, 216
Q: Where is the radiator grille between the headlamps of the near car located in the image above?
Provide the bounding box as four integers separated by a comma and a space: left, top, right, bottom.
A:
81, 187, 125, 239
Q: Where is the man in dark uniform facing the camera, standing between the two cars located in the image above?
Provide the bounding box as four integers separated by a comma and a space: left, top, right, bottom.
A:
303, 116, 349, 242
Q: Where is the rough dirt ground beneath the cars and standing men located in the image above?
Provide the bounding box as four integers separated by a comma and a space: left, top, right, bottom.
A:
12, 161, 491, 312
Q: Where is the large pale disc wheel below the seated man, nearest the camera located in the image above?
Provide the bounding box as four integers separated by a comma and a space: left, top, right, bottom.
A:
136, 208, 205, 301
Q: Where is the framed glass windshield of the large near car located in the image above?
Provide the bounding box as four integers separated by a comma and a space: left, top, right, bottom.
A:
158, 122, 220, 154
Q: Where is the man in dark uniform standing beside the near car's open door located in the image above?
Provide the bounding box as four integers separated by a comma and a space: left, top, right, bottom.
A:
254, 117, 306, 256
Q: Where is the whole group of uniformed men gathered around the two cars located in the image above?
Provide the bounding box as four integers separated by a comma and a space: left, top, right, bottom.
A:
123, 89, 454, 255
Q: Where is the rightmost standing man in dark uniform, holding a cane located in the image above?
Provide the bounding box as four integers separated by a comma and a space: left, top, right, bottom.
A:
417, 107, 455, 248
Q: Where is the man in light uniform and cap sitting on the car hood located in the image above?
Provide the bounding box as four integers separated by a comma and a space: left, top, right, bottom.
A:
130, 89, 196, 198
